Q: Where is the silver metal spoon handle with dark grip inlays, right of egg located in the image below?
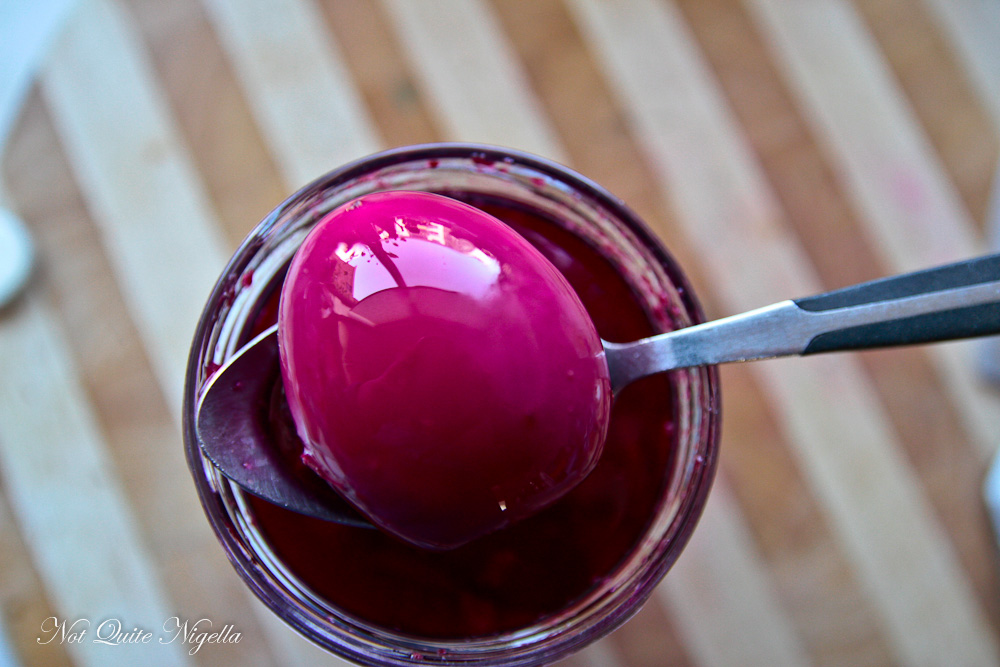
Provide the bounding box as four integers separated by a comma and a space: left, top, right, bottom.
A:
605, 255, 1000, 390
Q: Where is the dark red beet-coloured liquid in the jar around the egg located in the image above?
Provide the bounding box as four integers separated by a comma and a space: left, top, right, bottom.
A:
250, 201, 674, 639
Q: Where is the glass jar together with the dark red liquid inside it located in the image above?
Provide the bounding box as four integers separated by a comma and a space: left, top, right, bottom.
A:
185, 144, 719, 665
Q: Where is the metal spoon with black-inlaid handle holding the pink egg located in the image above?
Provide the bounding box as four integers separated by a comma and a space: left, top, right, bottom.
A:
196, 254, 1000, 526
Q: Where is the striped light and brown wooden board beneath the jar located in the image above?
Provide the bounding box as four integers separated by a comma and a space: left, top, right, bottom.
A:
0, 0, 1000, 667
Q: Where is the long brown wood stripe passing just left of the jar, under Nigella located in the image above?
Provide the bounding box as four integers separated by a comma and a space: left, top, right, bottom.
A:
6, 88, 282, 666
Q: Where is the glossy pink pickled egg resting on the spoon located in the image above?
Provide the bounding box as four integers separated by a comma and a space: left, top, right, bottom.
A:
278, 192, 611, 549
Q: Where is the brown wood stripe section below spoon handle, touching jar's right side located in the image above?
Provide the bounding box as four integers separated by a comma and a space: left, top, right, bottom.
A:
720, 365, 895, 667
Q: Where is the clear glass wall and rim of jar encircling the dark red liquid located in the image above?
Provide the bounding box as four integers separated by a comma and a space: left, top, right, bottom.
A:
184, 144, 720, 665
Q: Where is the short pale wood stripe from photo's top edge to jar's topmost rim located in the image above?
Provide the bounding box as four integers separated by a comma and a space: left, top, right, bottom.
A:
384, 0, 564, 160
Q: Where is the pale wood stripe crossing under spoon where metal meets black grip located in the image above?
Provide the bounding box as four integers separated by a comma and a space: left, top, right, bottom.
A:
571, 0, 997, 664
